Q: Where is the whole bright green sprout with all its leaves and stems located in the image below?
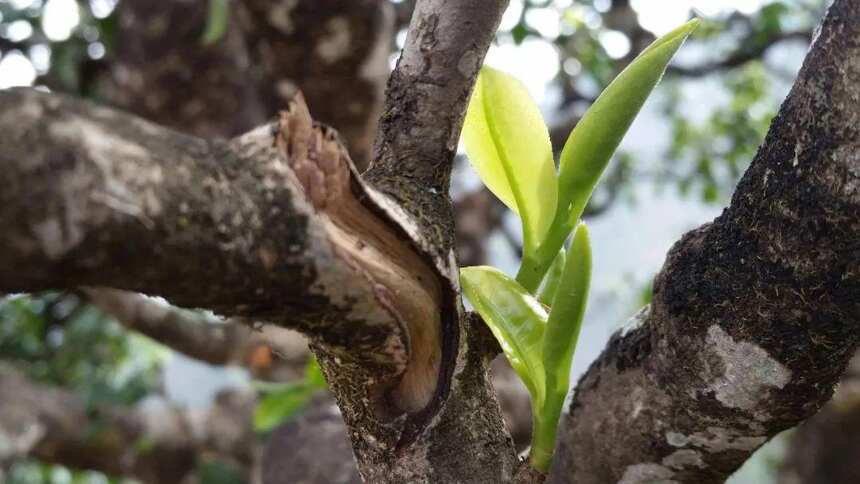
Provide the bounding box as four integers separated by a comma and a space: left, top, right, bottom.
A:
460, 20, 698, 472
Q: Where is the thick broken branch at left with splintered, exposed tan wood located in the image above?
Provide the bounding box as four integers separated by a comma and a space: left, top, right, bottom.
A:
0, 86, 439, 408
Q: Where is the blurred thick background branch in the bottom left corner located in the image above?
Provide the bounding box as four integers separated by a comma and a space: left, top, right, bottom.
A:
0, 365, 259, 483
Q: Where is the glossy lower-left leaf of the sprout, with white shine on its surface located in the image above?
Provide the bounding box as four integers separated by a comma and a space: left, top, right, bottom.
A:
460, 266, 547, 409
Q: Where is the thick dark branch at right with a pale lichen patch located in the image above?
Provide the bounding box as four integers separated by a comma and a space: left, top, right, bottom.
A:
551, 0, 860, 483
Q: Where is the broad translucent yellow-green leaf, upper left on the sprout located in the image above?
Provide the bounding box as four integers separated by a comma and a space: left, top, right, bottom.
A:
463, 67, 558, 251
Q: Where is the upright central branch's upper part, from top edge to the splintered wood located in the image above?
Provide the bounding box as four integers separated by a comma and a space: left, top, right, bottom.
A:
366, 0, 508, 272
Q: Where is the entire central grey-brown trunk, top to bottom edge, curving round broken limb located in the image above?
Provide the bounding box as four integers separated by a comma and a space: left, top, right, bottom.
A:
320, 0, 517, 483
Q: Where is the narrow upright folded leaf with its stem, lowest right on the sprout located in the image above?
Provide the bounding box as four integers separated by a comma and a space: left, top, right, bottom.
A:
529, 224, 591, 470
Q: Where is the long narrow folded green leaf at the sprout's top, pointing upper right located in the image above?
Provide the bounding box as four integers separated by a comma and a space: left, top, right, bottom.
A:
559, 19, 699, 224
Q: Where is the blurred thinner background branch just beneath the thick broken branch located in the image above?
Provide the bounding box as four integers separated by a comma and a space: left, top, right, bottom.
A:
83, 288, 310, 381
